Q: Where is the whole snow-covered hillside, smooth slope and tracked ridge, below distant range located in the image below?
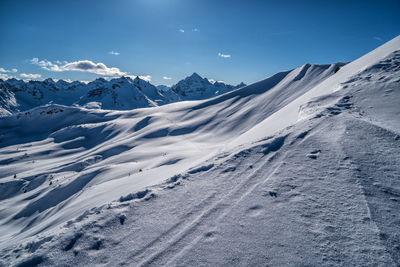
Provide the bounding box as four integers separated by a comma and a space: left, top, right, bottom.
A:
0, 37, 400, 266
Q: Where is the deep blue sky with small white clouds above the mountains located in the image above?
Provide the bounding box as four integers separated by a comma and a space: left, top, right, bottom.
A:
0, 0, 400, 85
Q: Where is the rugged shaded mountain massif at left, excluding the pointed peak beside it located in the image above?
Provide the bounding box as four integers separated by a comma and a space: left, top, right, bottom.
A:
0, 77, 169, 114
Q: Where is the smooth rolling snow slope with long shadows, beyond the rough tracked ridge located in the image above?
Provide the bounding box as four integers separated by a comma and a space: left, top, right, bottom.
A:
0, 64, 344, 249
